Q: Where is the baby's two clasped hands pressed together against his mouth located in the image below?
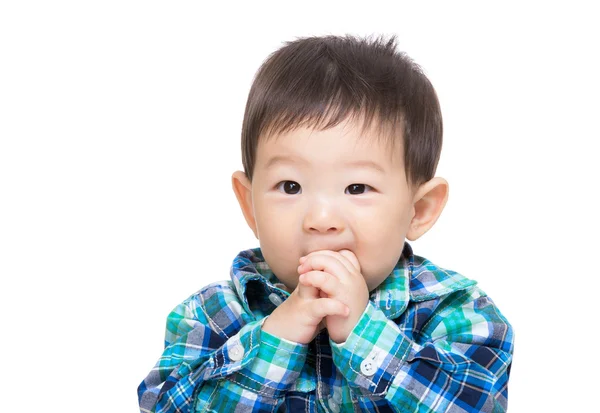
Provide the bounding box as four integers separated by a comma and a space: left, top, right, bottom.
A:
263, 250, 369, 344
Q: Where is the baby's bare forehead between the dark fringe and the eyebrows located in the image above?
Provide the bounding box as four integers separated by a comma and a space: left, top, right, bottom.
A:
256, 117, 402, 172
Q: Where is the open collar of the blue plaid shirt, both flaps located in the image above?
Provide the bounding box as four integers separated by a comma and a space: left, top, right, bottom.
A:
231, 242, 475, 320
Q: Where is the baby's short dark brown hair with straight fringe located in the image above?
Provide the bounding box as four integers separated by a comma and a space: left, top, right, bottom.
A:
242, 35, 442, 188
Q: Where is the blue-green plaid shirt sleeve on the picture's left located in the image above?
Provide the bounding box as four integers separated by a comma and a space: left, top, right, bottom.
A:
138, 286, 308, 412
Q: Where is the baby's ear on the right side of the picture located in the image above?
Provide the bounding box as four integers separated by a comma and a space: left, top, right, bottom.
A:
406, 177, 449, 241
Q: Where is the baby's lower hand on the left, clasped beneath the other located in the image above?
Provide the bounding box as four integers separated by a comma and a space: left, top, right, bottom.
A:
262, 268, 349, 344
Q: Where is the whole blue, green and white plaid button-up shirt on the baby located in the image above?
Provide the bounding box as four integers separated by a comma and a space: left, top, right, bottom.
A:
138, 242, 513, 413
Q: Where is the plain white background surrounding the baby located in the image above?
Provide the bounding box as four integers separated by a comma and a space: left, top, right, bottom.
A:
0, 1, 600, 413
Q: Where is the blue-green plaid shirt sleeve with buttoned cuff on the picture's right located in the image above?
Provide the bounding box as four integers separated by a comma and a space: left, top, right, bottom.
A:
330, 287, 513, 413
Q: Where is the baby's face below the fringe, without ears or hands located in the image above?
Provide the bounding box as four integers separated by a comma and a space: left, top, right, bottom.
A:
237, 121, 414, 291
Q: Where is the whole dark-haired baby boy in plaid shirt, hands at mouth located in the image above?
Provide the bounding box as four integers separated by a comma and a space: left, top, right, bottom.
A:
138, 36, 513, 412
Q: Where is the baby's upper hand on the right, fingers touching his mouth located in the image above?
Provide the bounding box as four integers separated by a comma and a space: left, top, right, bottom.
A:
298, 250, 369, 343
